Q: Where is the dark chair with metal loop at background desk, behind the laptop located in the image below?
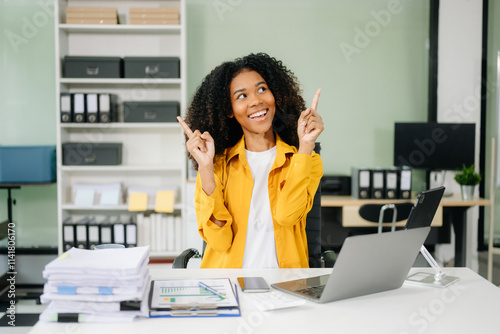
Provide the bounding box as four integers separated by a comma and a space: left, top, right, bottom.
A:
359, 202, 413, 233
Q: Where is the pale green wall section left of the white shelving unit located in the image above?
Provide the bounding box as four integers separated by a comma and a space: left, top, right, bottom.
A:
0, 0, 57, 247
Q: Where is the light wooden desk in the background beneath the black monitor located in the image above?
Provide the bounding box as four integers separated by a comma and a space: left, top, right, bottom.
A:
321, 195, 491, 267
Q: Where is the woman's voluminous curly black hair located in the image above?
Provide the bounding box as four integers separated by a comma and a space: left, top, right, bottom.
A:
185, 53, 306, 170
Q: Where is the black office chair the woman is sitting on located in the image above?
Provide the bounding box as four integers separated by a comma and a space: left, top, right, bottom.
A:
172, 143, 337, 268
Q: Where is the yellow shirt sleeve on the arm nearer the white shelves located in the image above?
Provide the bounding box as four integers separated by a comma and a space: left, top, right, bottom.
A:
195, 168, 233, 251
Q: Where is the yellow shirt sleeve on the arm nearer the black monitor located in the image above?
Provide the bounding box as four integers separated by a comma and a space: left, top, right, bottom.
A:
275, 152, 323, 226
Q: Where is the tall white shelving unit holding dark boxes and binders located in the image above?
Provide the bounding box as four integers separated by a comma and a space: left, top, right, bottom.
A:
55, 0, 187, 258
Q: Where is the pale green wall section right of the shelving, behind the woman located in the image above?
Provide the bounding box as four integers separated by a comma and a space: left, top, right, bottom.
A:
188, 0, 429, 174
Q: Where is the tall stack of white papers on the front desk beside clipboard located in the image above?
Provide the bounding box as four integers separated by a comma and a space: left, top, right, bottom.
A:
40, 246, 151, 322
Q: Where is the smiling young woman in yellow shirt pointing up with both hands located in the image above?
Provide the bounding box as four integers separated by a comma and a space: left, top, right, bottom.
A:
178, 53, 324, 268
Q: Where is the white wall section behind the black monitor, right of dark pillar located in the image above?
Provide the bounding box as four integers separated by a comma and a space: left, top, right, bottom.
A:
436, 0, 483, 272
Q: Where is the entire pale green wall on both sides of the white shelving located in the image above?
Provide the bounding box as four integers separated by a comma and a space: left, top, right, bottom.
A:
0, 0, 429, 246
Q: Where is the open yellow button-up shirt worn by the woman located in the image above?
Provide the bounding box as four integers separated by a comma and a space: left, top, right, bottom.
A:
195, 134, 323, 268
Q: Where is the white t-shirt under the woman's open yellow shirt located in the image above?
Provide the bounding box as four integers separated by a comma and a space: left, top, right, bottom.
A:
242, 146, 279, 268
